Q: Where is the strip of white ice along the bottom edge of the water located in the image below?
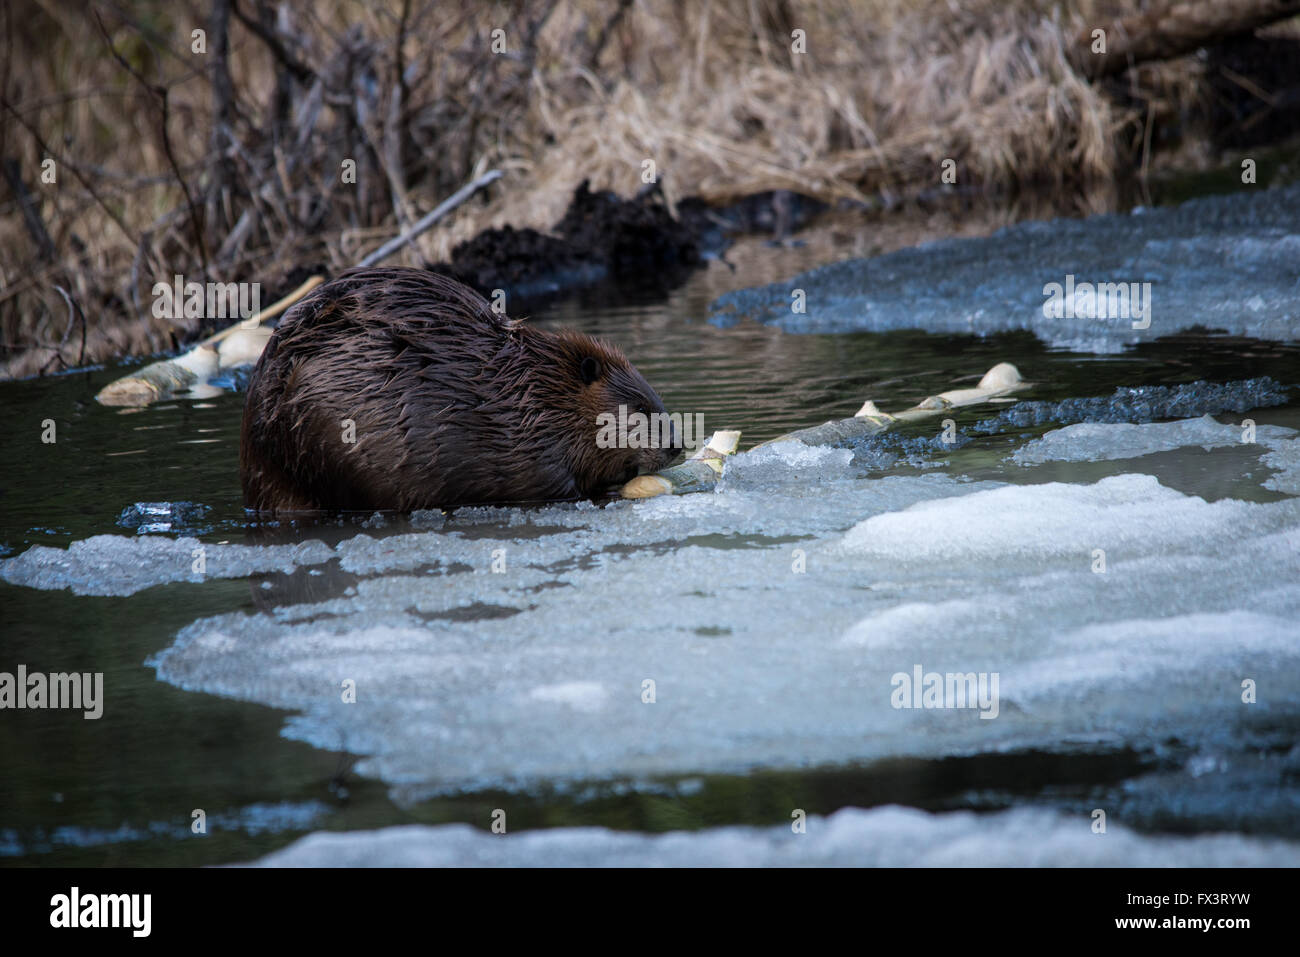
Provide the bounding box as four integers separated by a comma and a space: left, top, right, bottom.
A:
245, 806, 1300, 867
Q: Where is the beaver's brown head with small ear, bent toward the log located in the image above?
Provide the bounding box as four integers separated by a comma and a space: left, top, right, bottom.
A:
546, 330, 681, 495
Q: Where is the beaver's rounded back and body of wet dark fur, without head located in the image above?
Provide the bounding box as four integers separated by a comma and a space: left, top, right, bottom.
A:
241, 269, 577, 511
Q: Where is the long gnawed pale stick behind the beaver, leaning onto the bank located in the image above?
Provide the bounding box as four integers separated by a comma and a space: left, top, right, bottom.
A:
95, 169, 502, 406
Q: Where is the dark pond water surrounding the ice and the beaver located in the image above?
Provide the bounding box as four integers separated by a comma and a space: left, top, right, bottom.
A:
0, 231, 1300, 865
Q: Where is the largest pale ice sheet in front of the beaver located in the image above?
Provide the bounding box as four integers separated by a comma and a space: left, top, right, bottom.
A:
126, 462, 1300, 800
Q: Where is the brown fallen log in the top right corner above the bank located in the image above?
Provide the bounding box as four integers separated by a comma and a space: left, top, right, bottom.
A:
1070, 0, 1300, 79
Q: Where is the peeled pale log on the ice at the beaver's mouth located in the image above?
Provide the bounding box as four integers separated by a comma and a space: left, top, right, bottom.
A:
621, 363, 1030, 498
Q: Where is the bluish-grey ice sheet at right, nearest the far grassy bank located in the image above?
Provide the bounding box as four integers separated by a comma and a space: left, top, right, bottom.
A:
714, 185, 1300, 352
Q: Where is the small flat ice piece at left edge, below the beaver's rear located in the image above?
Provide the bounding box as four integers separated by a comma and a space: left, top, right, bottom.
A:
0, 534, 334, 596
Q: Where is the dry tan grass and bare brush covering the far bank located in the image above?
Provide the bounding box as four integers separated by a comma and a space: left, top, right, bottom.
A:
0, 0, 1237, 376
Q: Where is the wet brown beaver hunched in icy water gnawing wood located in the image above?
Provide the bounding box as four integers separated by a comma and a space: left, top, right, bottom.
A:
239, 268, 680, 512
